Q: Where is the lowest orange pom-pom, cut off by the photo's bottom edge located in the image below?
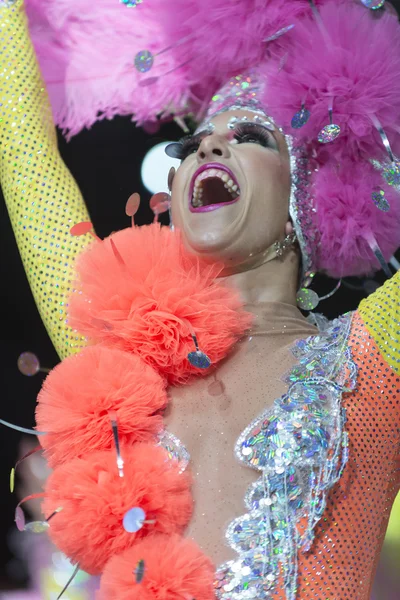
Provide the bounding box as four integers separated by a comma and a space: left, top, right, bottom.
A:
99, 535, 215, 600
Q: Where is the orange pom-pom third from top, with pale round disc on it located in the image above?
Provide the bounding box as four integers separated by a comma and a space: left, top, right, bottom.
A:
43, 444, 193, 575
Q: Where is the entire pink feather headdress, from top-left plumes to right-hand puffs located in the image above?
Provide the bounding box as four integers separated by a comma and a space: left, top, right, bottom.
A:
27, 0, 400, 277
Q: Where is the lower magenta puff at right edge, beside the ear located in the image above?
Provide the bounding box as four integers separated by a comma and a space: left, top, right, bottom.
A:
314, 160, 400, 278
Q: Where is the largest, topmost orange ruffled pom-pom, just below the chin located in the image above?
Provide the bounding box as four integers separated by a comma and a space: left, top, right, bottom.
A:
70, 225, 250, 384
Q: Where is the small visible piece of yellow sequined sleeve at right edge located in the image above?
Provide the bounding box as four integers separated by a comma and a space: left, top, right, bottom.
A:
358, 272, 400, 375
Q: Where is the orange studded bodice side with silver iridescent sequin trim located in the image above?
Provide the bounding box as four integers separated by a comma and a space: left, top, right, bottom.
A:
166, 302, 400, 600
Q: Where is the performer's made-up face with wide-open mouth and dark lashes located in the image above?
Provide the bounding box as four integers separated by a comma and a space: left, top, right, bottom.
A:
171, 110, 290, 266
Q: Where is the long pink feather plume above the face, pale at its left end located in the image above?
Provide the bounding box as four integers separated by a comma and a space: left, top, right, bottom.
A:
27, 0, 325, 135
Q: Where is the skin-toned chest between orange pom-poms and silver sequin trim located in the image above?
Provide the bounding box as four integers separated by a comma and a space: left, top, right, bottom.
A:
165, 335, 304, 564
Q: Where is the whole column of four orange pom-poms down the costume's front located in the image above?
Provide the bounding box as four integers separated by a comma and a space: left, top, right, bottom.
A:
37, 225, 250, 600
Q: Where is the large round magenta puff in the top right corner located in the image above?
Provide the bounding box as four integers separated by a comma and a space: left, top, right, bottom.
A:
265, 2, 400, 160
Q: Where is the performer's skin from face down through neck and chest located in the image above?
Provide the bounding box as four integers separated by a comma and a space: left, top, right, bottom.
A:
165, 111, 315, 565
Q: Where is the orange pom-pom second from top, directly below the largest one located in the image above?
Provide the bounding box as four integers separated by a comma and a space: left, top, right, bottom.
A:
36, 346, 167, 467
